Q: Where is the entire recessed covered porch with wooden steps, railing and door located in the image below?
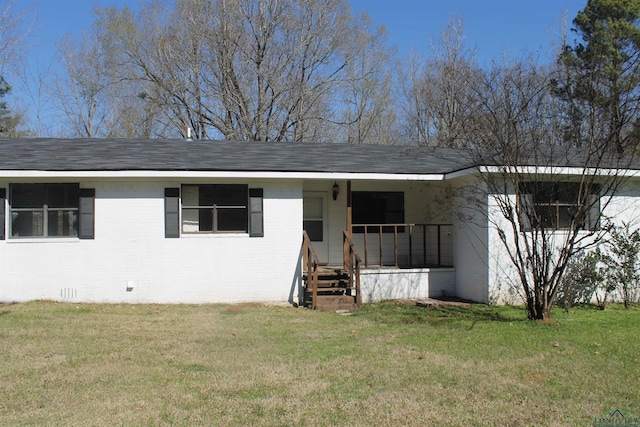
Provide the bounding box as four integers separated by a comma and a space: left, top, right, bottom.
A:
301, 180, 455, 310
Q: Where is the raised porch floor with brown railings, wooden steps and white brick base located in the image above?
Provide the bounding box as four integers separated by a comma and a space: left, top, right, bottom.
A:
302, 223, 455, 311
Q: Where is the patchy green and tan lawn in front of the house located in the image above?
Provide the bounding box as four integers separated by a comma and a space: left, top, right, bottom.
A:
0, 302, 640, 426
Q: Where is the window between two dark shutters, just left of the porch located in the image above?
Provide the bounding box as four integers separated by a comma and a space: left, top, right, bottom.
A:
182, 184, 249, 233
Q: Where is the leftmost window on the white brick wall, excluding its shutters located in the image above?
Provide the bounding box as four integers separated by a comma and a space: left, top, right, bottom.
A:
9, 184, 80, 238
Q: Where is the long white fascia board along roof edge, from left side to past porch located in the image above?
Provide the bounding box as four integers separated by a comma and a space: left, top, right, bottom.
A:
0, 170, 444, 181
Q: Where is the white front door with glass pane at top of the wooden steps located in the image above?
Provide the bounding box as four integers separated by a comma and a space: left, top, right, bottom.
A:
302, 191, 329, 263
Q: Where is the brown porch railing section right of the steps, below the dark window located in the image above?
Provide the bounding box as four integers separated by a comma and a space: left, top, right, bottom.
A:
352, 224, 453, 268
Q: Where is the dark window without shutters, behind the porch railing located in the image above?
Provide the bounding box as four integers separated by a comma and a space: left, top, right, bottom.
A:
351, 191, 404, 233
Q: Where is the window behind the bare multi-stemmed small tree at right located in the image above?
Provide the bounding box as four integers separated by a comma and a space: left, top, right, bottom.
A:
519, 182, 600, 230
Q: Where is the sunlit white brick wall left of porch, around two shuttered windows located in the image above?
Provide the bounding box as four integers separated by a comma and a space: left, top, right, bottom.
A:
0, 180, 302, 303
